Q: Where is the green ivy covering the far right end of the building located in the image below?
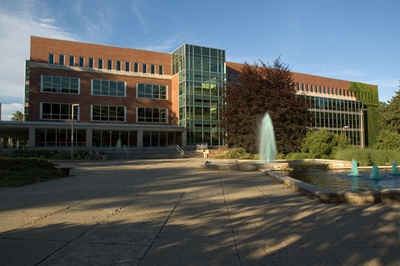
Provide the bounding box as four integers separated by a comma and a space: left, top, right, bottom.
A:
349, 82, 379, 146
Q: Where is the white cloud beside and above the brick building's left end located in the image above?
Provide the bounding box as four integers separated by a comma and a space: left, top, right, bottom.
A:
0, 5, 77, 101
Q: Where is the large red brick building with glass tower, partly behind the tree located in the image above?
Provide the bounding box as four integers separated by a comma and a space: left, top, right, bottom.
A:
0, 36, 378, 149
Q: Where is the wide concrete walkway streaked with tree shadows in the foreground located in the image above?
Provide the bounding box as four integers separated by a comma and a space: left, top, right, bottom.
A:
0, 159, 400, 266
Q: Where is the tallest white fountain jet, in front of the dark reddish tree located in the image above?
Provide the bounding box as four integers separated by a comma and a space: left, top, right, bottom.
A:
258, 113, 277, 163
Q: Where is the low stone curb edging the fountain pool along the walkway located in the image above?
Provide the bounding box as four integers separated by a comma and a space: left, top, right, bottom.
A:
259, 169, 400, 205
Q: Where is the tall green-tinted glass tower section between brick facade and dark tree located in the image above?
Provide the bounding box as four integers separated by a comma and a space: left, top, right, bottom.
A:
173, 44, 226, 146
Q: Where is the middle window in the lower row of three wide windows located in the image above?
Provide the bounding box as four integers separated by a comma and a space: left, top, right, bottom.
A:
91, 104, 125, 122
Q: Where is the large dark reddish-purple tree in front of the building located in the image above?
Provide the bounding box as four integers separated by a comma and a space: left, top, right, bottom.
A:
222, 58, 311, 153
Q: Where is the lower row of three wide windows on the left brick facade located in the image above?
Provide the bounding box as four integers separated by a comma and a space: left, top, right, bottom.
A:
40, 103, 168, 123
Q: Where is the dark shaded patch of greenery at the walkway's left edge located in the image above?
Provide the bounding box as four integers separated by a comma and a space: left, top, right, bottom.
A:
0, 157, 61, 187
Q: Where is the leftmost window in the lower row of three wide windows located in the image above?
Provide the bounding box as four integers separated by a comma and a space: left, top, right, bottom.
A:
40, 103, 79, 120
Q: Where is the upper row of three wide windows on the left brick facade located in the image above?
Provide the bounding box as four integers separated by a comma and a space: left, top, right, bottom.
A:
40, 75, 168, 100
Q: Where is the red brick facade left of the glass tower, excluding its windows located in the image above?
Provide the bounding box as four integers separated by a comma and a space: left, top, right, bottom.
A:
27, 37, 178, 125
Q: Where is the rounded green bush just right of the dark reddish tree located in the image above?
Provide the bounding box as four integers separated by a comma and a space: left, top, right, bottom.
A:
301, 129, 349, 158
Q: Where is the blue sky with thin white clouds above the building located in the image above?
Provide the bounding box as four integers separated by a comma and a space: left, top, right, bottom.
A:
0, 0, 400, 120
